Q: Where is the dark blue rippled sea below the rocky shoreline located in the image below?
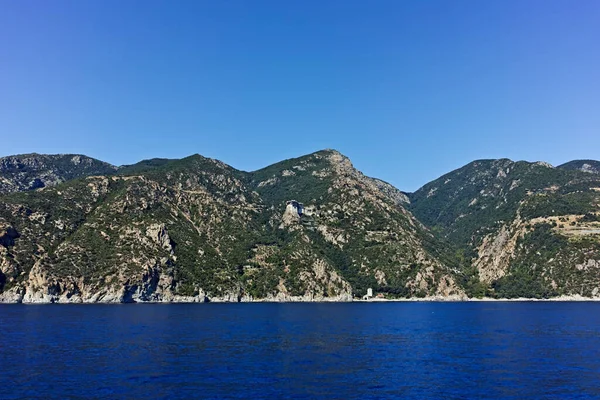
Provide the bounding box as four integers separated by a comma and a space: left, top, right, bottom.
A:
0, 303, 600, 399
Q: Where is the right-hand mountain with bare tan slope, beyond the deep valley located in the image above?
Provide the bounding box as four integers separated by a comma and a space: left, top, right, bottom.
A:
409, 159, 600, 297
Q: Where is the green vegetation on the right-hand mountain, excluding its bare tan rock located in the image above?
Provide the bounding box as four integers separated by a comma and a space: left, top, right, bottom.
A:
410, 160, 600, 298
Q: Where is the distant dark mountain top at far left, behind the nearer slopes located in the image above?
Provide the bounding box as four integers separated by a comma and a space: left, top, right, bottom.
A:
0, 154, 117, 194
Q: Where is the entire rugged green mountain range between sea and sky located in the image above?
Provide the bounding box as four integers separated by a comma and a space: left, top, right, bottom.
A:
0, 149, 600, 302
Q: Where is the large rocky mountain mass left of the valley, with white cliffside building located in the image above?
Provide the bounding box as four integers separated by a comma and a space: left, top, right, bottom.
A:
0, 150, 464, 302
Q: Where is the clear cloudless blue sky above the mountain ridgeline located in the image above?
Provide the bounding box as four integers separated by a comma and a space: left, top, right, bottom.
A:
0, 0, 600, 191
